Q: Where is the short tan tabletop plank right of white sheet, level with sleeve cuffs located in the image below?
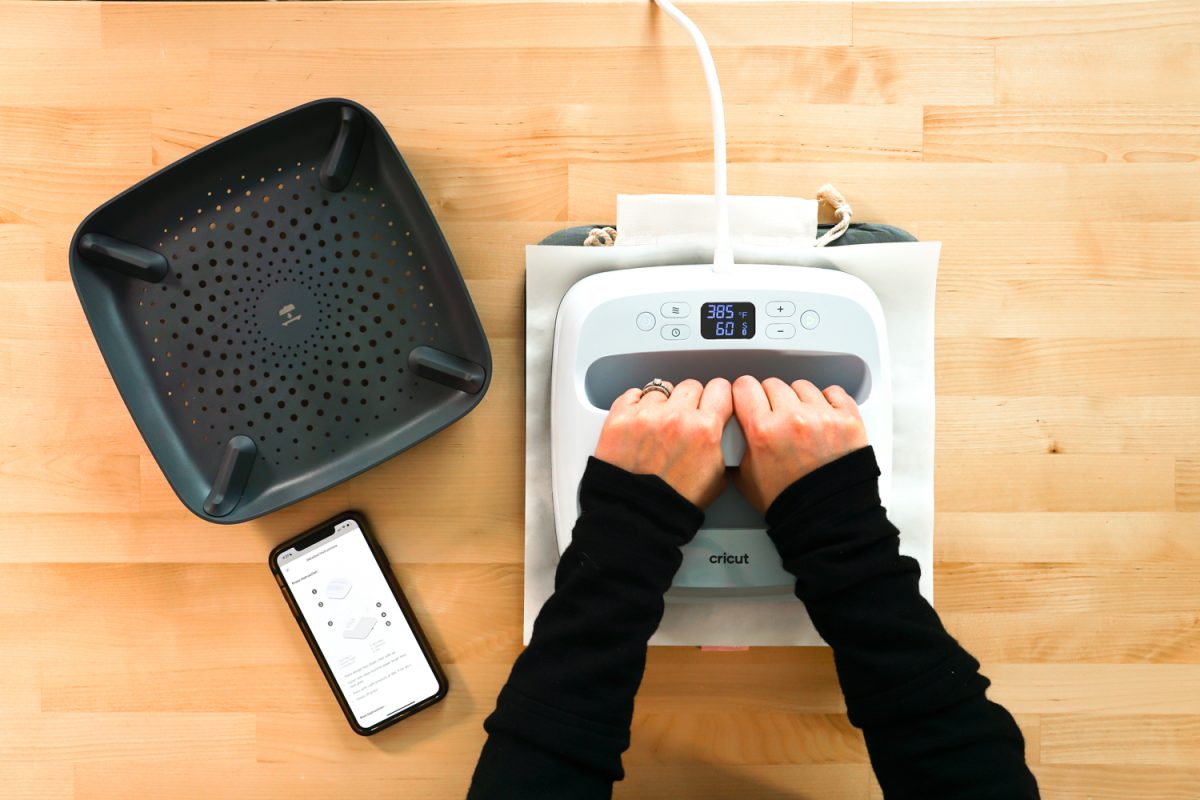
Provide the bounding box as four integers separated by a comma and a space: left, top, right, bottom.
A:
934, 453, 1175, 511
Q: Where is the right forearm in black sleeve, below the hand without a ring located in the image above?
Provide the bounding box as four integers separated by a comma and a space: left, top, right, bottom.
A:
767, 447, 1038, 800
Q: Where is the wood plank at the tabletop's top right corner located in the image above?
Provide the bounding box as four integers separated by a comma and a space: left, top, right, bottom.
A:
853, 0, 1200, 49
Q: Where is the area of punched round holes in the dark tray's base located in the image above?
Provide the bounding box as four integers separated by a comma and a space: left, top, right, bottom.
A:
138, 161, 440, 472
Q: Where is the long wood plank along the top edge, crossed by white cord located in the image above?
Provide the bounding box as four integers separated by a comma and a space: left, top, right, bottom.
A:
101, 1, 851, 52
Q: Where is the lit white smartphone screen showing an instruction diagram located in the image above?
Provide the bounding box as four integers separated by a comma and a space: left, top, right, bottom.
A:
276, 519, 438, 728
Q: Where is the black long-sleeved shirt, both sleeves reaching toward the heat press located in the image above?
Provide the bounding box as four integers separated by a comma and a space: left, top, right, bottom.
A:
468, 447, 1038, 800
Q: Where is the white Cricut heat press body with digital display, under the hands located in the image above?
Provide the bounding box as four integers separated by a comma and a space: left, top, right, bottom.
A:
551, 264, 892, 600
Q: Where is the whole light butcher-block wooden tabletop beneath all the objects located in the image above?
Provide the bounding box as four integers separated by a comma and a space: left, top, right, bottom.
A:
0, 0, 1200, 800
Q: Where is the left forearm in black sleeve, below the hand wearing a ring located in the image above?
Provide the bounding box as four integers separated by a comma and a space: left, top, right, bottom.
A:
468, 458, 704, 800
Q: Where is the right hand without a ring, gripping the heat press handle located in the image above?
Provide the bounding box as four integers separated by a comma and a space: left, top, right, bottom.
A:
733, 375, 866, 513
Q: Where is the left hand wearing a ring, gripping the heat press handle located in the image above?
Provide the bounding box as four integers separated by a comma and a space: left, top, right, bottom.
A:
595, 378, 733, 509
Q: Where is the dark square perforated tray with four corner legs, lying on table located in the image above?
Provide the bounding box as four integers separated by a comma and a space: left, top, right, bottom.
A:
71, 100, 492, 523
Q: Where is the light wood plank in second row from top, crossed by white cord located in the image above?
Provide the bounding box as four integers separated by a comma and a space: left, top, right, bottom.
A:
206, 46, 994, 107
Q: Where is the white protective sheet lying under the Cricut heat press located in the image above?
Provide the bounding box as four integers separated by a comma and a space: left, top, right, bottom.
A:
524, 196, 941, 646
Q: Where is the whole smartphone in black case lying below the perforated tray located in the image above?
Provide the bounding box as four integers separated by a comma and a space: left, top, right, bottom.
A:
270, 511, 448, 736
